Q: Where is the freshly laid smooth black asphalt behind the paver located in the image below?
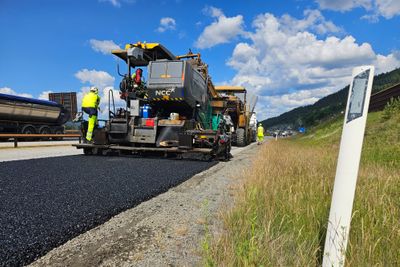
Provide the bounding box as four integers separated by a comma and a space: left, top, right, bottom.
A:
0, 156, 215, 266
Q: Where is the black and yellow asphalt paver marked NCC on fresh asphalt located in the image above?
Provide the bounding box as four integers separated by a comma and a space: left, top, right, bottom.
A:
75, 42, 231, 159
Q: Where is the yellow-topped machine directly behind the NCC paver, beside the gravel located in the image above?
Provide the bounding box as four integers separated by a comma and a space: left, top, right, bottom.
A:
215, 85, 257, 147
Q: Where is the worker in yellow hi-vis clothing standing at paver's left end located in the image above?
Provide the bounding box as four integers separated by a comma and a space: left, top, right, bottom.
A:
82, 86, 100, 142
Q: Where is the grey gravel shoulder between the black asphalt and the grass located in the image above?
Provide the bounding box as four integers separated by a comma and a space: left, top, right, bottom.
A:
30, 144, 258, 266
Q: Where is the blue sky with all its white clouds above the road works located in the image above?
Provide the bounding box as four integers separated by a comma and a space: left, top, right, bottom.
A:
0, 0, 400, 119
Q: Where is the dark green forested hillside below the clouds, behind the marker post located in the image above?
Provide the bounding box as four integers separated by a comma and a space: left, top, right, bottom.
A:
262, 68, 400, 128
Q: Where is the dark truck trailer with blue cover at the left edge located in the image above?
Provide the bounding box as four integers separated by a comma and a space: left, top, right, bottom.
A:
0, 94, 70, 138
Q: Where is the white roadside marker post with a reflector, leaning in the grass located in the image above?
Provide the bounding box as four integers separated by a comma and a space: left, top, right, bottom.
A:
322, 66, 374, 267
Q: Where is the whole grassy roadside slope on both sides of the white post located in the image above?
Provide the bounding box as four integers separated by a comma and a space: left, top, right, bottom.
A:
203, 100, 400, 266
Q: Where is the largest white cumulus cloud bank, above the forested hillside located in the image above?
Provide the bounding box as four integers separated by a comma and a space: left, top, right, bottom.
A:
227, 10, 400, 119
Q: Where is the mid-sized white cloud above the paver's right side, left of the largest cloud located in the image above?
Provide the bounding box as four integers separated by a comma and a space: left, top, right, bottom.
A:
195, 7, 246, 48
